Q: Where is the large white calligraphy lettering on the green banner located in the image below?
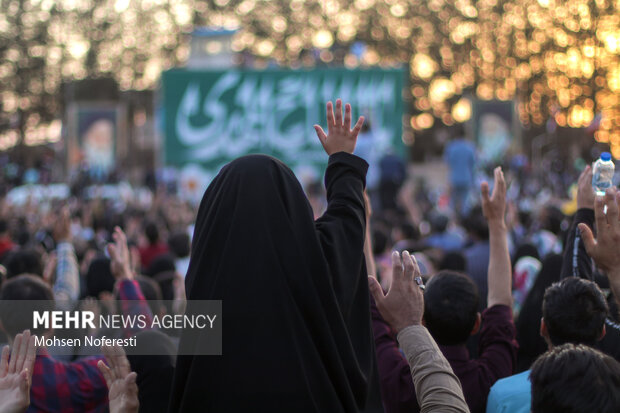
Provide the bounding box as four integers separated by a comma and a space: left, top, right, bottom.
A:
174, 71, 401, 162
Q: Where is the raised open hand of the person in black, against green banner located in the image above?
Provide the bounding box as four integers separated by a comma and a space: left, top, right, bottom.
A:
314, 99, 364, 155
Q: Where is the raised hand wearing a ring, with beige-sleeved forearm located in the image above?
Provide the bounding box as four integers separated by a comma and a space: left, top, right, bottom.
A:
368, 251, 469, 413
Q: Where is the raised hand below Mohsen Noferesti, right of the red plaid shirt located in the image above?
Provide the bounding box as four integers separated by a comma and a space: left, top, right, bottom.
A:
97, 346, 140, 413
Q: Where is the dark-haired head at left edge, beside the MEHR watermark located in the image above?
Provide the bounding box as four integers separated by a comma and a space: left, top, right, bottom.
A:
0, 274, 55, 337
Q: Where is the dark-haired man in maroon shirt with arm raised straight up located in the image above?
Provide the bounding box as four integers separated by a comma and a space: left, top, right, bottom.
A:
372, 168, 517, 413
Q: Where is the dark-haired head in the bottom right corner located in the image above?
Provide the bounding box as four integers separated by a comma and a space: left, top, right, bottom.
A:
530, 344, 620, 413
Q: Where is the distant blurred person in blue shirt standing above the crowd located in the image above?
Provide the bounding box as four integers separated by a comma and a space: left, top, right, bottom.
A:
444, 127, 476, 217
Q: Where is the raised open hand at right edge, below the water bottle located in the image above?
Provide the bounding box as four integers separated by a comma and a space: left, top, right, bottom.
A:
579, 188, 620, 306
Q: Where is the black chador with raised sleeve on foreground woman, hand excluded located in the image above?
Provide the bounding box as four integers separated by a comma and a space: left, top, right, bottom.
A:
170, 152, 378, 413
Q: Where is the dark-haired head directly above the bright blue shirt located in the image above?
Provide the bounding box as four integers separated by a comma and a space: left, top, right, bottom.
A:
543, 277, 609, 346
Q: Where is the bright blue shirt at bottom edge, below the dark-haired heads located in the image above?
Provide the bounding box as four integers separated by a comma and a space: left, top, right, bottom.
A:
487, 370, 532, 413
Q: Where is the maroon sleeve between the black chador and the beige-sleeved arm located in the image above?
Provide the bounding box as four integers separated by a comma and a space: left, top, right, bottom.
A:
370, 297, 420, 413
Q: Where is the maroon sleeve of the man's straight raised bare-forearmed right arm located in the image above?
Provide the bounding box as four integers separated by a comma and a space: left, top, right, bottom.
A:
478, 305, 519, 389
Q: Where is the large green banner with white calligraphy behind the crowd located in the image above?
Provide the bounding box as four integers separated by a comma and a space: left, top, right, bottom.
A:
161, 69, 405, 200
